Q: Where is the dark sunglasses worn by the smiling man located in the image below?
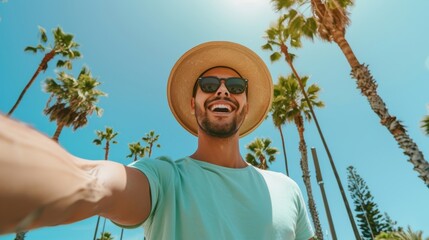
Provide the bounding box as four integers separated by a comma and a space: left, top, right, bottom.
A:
198, 77, 247, 94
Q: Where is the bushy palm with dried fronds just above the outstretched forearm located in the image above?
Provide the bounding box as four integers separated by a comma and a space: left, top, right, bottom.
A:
44, 67, 106, 141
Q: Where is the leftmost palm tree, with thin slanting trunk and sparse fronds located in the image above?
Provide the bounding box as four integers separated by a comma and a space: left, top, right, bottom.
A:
8, 26, 81, 116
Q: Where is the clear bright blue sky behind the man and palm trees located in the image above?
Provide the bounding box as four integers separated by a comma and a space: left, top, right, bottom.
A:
0, 0, 429, 240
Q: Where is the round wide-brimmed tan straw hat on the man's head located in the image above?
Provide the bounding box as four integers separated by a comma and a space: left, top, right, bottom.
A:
167, 41, 273, 137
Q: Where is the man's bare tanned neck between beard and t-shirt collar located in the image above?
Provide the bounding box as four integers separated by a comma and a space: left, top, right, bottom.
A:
190, 133, 248, 168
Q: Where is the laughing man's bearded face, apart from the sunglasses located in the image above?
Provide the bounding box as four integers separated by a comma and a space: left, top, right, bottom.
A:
192, 67, 248, 138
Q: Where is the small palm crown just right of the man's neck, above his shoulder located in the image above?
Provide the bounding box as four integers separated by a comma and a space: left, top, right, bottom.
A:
246, 138, 278, 170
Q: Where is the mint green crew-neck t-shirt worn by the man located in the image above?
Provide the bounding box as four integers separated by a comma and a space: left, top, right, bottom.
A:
125, 157, 313, 240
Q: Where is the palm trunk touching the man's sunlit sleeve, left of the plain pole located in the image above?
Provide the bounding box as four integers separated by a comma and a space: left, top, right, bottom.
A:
295, 116, 323, 240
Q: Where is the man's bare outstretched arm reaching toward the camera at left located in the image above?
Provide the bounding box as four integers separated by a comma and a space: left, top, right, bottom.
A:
0, 116, 150, 234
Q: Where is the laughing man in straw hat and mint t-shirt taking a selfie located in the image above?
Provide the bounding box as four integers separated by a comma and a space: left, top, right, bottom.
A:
0, 42, 313, 240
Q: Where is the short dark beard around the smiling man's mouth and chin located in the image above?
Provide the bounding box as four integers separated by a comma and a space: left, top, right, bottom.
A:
195, 98, 246, 138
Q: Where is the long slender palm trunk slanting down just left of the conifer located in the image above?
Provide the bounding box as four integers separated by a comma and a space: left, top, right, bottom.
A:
281, 44, 361, 240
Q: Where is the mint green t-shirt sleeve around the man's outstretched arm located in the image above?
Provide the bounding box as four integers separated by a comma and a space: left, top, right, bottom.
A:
113, 157, 175, 228
